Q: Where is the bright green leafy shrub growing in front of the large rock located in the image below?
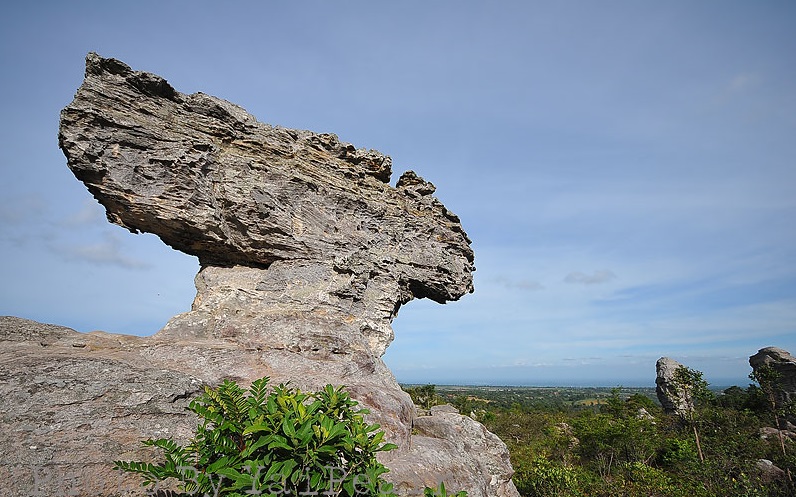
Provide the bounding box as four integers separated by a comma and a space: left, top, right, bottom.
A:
114, 377, 396, 497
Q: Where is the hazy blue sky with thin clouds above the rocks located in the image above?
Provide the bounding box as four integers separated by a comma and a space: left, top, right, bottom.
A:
0, 0, 796, 385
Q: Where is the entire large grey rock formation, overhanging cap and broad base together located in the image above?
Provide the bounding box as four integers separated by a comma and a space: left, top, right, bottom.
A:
0, 54, 517, 497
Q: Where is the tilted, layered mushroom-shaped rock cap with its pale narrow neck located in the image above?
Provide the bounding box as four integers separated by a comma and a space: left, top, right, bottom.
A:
59, 53, 474, 355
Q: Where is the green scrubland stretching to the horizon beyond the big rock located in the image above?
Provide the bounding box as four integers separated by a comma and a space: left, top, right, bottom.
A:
406, 369, 796, 497
